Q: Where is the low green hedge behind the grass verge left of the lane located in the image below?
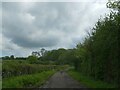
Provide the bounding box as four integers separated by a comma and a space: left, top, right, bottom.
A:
2, 60, 59, 78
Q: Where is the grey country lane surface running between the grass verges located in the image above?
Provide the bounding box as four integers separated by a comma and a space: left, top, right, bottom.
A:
42, 72, 84, 88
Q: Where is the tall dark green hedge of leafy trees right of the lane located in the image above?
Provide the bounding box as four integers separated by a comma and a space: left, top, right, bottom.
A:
72, 1, 120, 86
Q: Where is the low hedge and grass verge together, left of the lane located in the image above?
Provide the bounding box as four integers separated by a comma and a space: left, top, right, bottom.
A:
1, 56, 68, 88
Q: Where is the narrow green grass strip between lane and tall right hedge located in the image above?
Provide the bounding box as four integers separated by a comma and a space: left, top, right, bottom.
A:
68, 70, 115, 88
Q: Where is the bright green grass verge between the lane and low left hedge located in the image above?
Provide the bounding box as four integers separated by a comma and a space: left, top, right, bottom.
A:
2, 71, 55, 88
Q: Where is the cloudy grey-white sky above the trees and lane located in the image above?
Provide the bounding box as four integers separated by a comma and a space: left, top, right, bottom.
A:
0, 0, 109, 56
